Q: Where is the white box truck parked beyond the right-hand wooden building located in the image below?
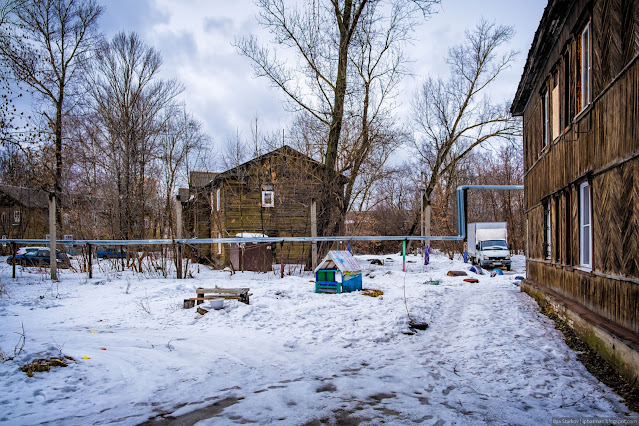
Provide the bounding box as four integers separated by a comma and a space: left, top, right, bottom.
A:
466, 222, 511, 271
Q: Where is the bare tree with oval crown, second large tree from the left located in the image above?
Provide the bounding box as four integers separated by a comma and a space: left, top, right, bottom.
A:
85, 33, 182, 238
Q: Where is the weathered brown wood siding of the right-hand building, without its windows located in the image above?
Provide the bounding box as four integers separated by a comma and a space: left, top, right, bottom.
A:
524, 0, 639, 333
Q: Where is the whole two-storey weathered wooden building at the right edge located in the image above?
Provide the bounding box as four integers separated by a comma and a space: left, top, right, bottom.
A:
511, 0, 639, 383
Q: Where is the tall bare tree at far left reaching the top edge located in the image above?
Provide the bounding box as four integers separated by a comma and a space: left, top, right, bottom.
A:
0, 0, 102, 231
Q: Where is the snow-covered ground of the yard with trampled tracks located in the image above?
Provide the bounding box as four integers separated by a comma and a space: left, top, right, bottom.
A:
0, 251, 628, 425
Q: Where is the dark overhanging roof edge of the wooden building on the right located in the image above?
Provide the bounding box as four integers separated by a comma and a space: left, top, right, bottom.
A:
510, 0, 575, 116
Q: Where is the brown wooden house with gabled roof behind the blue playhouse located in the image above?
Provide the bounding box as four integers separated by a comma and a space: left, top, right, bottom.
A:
182, 145, 345, 266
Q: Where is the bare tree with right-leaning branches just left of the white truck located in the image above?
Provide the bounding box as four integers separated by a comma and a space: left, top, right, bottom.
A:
413, 20, 521, 235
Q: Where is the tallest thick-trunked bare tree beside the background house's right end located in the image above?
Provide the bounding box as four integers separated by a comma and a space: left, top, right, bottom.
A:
236, 0, 438, 243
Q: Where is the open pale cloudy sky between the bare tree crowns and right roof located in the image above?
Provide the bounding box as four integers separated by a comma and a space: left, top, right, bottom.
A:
101, 0, 547, 160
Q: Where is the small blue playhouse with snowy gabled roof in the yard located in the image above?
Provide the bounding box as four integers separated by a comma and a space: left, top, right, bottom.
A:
315, 250, 362, 293
